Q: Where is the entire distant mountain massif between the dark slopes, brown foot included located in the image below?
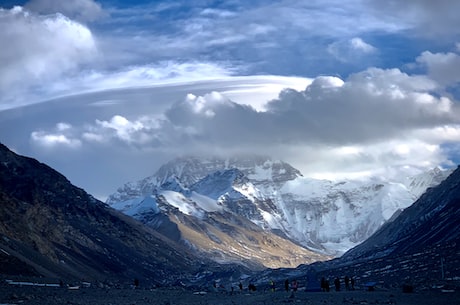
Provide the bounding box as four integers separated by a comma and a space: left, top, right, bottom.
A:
107, 156, 450, 267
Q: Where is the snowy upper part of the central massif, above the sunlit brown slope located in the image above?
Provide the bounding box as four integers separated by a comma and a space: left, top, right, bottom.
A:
107, 157, 449, 266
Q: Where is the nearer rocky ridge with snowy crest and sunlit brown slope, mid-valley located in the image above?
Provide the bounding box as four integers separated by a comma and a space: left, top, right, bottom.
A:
112, 168, 328, 269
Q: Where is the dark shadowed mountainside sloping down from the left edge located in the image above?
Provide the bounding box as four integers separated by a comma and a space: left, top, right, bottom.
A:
0, 144, 214, 283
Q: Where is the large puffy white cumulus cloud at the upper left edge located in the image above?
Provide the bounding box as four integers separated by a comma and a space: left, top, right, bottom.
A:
0, 7, 97, 107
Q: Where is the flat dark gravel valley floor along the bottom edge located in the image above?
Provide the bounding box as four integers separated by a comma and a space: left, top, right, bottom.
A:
0, 285, 460, 305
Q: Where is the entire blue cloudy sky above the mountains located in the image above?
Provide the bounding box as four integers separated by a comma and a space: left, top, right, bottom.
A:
0, 0, 460, 199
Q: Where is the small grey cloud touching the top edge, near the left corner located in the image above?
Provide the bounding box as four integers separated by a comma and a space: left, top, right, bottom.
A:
24, 0, 104, 22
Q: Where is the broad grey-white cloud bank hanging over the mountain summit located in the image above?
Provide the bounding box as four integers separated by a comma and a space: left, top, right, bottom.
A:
15, 68, 460, 196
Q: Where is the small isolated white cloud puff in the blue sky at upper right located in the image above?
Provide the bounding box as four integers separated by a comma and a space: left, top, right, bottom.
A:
327, 37, 377, 62
